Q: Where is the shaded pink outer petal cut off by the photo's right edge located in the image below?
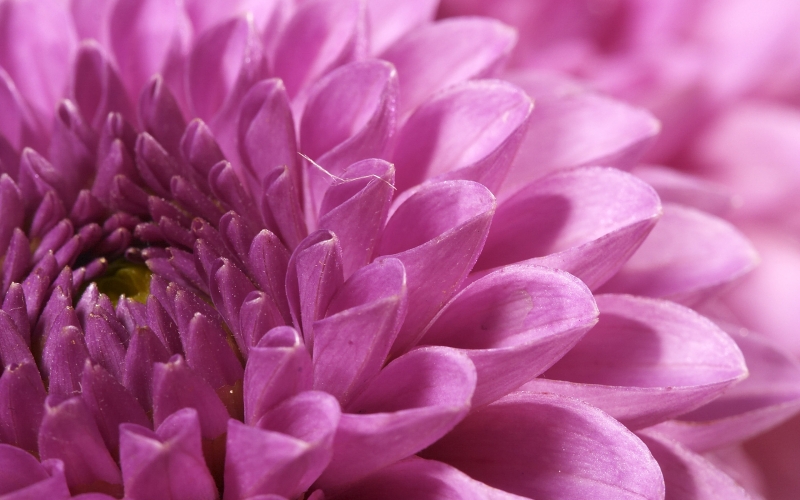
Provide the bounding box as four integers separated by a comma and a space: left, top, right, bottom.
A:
654, 329, 800, 453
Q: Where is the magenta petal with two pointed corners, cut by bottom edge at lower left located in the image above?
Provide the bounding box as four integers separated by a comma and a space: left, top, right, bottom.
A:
120, 408, 219, 500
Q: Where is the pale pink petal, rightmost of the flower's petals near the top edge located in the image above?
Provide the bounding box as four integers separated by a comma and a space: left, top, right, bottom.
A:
380, 18, 517, 120
